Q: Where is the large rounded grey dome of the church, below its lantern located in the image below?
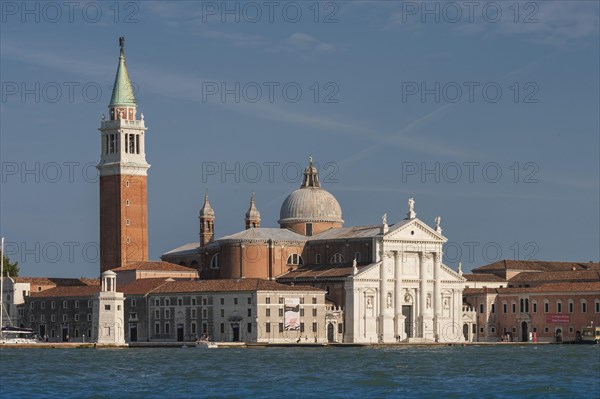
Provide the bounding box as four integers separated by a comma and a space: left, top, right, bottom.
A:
279, 187, 344, 224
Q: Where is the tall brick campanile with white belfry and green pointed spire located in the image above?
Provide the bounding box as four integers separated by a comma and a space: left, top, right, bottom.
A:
97, 37, 150, 273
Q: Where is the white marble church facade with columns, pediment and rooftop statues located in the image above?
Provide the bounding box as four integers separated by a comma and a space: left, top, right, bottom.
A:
344, 206, 466, 343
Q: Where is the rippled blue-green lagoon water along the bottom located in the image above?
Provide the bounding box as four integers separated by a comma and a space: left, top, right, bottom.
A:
0, 345, 600, 398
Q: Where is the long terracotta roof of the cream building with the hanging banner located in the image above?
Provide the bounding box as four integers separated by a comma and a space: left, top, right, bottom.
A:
152, 278, 323, 293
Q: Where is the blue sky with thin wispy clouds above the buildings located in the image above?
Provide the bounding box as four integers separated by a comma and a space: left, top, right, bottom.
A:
0, 1, 600, 277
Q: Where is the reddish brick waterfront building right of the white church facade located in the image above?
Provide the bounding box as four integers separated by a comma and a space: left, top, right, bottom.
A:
464, 260, 600, 342
